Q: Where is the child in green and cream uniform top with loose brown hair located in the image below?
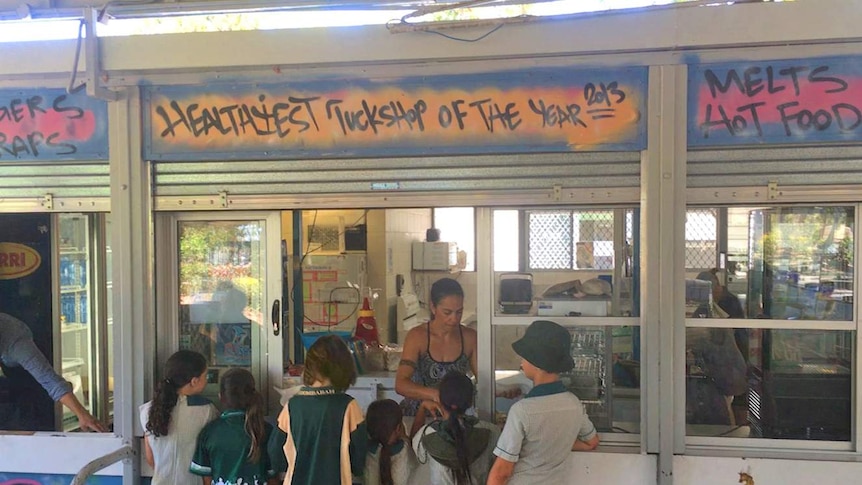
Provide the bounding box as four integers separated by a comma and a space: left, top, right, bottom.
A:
269, 335, 368, 485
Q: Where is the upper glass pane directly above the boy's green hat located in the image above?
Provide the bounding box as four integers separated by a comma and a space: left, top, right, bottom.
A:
500, 208, 640, 317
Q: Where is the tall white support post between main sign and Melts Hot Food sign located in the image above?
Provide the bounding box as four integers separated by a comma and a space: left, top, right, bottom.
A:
641, 65, 686, 485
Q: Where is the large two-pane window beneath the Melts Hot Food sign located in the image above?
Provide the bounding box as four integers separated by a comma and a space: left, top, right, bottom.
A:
685, 205, 858, 449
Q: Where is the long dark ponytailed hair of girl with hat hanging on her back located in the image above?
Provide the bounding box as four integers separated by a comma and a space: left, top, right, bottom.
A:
439, 371, 473, 485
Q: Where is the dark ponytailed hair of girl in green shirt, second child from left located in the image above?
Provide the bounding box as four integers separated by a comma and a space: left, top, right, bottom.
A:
219, 367, 266, 462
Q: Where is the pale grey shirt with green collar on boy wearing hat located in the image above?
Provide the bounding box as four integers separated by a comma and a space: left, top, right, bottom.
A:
494, 381, 596, 485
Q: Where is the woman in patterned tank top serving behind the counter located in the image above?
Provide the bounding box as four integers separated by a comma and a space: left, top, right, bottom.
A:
395, 278, 478, 416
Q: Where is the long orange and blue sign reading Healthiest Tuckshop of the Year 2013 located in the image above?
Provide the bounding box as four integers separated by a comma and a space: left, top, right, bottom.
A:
144, 67, 647, 160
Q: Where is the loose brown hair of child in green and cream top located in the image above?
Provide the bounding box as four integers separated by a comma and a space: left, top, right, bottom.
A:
302, 335, 356, 392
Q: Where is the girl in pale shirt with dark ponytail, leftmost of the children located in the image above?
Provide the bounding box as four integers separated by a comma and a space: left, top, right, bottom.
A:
140, 350, 218, 485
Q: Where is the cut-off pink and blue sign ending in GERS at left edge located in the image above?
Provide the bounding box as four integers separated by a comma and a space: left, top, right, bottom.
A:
0, 89, 108, 163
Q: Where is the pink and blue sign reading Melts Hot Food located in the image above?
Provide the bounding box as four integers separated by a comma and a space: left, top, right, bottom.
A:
688, 58, 862, 146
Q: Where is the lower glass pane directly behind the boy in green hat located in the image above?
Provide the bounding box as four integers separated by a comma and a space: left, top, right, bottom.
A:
494, 325, 640, 433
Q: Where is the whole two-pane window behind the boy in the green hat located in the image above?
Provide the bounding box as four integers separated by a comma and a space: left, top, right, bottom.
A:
491, 206, 641, 442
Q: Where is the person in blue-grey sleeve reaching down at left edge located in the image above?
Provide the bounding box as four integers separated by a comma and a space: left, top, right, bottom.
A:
0, 313, 106, 432
